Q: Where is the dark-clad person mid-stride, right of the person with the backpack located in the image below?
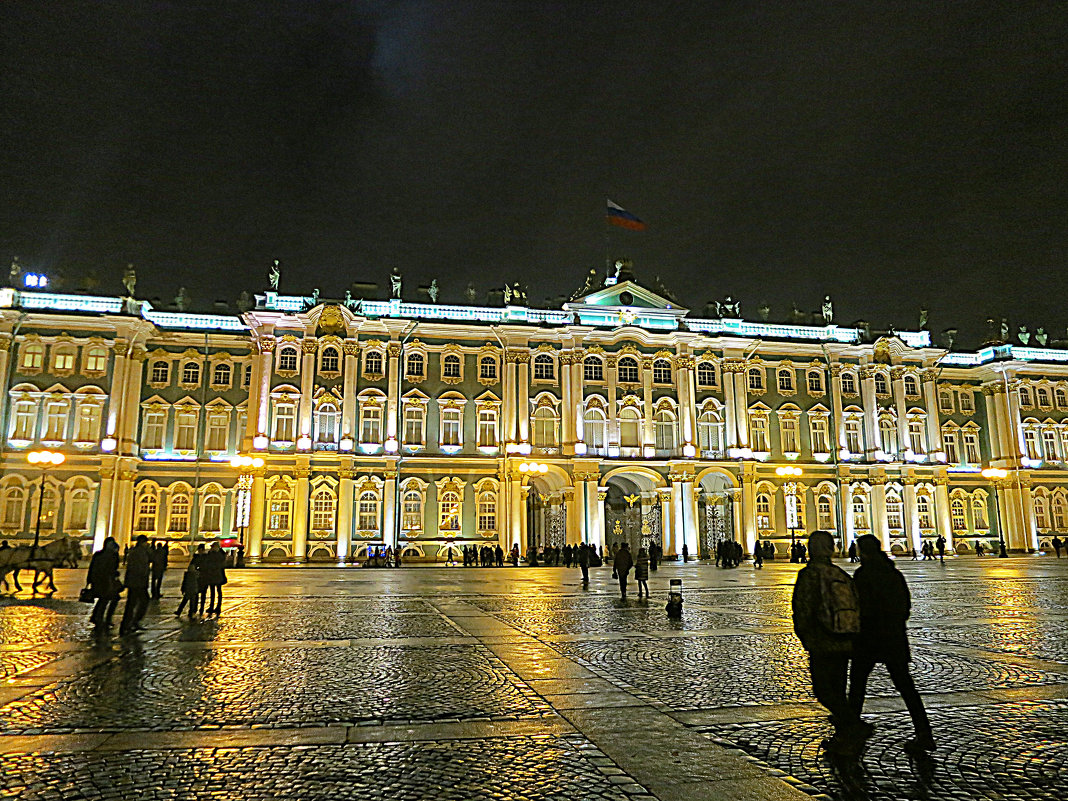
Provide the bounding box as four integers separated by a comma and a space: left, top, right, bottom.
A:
849, 534, 935, 751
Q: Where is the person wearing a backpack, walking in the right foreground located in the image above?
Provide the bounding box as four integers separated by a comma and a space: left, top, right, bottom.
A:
791, 531, 873, 756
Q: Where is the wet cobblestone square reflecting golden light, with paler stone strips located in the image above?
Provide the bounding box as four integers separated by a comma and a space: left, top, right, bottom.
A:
0, 557, 1068, 801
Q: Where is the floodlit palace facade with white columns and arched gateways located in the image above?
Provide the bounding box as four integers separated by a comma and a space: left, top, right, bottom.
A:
0, 277, 1068, 562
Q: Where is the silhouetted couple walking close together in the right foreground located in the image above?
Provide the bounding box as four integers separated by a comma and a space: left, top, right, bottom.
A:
792, 531, 935, 757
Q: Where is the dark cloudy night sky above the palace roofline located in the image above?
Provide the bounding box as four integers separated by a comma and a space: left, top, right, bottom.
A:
0, 0, 1068, 341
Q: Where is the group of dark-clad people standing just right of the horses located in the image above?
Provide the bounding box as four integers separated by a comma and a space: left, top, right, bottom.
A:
85, 534, 226, 635
